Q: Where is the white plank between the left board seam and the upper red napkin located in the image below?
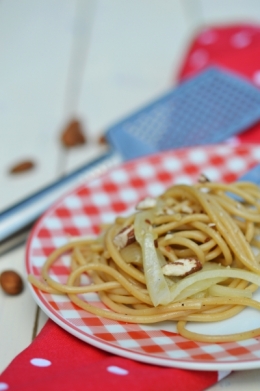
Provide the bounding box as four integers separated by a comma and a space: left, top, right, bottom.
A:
67, 0, 194, 171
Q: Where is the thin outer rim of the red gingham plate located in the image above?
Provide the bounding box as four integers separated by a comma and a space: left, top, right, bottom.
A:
25, 143, 260, 371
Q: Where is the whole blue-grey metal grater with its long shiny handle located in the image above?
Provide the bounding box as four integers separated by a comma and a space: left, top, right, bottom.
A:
0, 68, 260, 243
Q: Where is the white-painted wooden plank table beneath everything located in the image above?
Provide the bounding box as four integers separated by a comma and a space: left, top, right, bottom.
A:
0, 0, 260, 391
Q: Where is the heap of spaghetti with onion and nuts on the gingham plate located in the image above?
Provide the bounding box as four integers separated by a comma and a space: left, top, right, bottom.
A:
28, 180, 260, 342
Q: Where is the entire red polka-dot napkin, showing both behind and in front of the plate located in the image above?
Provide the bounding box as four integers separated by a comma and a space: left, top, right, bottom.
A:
0, 25, 260, 391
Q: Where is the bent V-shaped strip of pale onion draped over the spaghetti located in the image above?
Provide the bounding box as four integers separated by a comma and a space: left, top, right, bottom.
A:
134, 210, 260, 306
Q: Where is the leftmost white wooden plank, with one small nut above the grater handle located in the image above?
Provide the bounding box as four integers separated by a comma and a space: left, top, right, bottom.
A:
0, 0, 76, 210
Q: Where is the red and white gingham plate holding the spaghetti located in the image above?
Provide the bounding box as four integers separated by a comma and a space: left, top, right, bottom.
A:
26, 144, 260, 370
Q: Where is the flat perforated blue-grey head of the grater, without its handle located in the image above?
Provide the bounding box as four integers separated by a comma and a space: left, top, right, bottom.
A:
107, 68, 260, 159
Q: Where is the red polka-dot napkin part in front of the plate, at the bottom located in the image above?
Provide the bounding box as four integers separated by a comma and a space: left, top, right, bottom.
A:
0, 320, 227, 391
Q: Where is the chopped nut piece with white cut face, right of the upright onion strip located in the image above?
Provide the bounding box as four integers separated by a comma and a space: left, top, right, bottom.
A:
162, 258, 202, 277
